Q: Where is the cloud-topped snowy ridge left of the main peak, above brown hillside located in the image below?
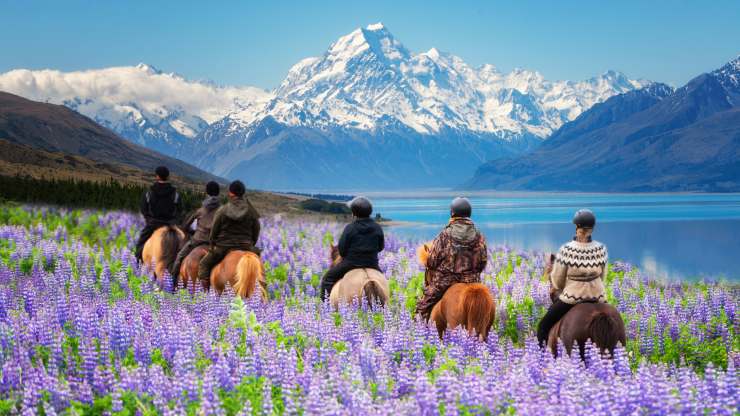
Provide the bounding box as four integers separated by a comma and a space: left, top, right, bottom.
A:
0, 64, 269, 155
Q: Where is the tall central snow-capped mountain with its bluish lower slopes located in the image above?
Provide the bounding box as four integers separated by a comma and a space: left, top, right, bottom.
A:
193, 24, 648, 189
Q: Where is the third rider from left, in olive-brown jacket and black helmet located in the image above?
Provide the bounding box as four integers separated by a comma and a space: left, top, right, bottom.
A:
198, 181, 260, 281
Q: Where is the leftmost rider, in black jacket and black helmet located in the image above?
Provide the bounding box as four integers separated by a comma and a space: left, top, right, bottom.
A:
135, 166, 182, 263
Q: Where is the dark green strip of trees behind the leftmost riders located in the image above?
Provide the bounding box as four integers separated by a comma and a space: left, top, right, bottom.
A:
0, 175, 204, 212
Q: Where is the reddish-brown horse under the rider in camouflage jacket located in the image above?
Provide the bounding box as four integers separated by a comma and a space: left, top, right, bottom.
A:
416, 243, 496, 341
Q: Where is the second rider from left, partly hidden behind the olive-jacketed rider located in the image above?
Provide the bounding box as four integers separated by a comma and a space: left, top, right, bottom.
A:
170, 181, 221, 284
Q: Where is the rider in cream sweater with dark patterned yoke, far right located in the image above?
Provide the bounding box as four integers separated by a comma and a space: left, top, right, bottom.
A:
537, 209, 608, 347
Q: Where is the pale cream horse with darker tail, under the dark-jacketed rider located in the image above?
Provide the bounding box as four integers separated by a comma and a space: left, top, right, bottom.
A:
329, 246, 390, 309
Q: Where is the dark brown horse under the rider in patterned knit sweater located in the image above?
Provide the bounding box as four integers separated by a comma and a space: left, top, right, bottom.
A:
547, 294, 627, 358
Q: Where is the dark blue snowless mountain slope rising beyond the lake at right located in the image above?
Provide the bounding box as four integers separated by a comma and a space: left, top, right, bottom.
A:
466, 56, 740, 192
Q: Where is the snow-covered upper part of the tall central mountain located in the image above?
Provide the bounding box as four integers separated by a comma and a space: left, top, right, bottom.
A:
225, 23, 646, 138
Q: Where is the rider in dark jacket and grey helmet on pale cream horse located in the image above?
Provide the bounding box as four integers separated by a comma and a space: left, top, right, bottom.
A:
320, 196, 385, 301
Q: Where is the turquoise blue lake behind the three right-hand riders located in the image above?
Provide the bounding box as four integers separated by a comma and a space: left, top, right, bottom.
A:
366, 191, 740, 282
